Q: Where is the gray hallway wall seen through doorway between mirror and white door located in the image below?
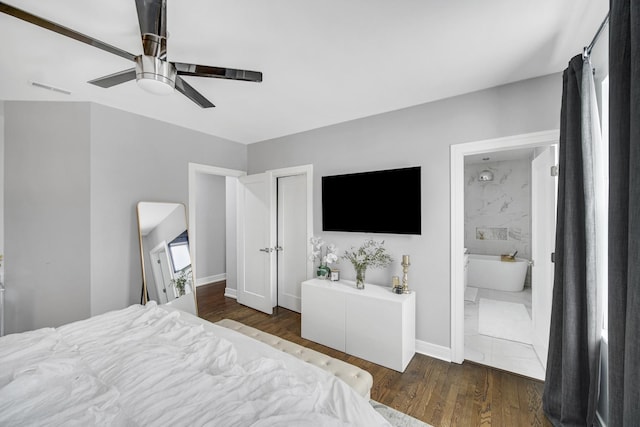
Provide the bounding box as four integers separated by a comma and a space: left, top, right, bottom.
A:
196, 173, 227, 284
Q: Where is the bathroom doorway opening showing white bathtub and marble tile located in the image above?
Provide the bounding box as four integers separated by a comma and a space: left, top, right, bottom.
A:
464, 146, 557, 379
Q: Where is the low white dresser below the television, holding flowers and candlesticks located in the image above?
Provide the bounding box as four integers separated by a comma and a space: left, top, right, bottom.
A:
302, 279, 416, 372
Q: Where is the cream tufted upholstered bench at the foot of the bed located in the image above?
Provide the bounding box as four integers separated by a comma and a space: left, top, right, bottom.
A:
216, 319, 373, 399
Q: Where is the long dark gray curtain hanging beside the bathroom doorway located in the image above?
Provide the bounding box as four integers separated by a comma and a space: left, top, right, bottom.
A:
542, 55, 601, 427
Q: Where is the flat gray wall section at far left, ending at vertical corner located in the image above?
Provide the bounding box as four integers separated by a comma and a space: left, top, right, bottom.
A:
4, 102, 91, 333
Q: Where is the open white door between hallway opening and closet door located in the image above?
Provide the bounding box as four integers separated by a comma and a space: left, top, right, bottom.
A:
237, 173, 275, 314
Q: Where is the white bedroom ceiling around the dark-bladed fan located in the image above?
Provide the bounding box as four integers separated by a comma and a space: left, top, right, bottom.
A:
0, 0, 609, 143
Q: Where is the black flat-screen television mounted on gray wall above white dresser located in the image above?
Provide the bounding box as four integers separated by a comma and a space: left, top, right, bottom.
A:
322, 166, 421, 234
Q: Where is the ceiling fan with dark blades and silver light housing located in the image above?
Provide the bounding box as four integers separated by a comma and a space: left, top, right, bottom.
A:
0, 0, 262, 108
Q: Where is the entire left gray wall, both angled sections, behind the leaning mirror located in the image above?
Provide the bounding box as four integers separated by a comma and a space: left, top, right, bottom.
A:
4, 101, 247, 332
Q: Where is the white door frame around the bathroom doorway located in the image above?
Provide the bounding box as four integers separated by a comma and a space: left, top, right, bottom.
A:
450, 129, 560, 363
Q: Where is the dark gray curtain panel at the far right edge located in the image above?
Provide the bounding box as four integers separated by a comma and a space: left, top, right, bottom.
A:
609, 0, 640, 427
